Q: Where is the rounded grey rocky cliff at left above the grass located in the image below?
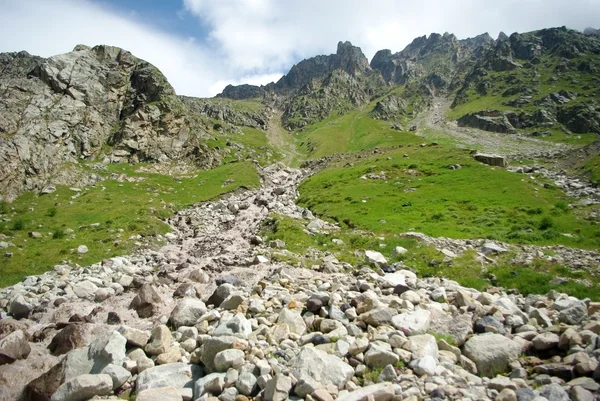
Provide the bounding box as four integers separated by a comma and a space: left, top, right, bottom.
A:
0, 45, 209, 200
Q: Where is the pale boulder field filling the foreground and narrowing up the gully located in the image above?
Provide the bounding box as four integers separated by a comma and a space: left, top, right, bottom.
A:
0, 160, 600, 401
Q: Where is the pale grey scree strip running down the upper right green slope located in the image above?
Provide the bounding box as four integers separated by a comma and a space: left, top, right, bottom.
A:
413, 98, 571, 158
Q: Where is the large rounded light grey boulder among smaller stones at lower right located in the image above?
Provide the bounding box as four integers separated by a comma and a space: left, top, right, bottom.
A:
463, 333, 521, 377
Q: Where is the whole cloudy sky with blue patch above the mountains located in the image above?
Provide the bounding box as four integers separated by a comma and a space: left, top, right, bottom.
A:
0, 0, 600, 96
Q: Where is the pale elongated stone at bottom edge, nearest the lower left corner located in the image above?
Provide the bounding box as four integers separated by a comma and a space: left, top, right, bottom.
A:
50, 374, 113, 401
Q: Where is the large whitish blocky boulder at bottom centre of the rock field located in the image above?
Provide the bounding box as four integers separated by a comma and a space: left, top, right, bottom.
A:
290, 347, 354, 390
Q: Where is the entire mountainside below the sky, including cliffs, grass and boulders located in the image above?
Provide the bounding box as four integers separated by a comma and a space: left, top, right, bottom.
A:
0, 27, 600, 401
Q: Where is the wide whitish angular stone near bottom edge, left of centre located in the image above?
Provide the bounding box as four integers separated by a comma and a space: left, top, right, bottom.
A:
136, 362, 202, 392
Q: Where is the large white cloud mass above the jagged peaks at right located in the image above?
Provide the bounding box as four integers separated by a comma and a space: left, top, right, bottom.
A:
184, 0, 600, 70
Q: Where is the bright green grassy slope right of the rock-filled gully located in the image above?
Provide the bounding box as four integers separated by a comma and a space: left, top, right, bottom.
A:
299, 146, 600, 249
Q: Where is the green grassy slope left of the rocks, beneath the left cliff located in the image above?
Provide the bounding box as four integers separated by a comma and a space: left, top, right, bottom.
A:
0, 163, 259, 286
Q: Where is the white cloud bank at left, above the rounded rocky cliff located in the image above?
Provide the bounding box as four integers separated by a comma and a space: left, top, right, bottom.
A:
0, 0, 278, 96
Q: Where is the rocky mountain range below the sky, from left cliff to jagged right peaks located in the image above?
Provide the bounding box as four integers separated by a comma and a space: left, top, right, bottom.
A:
0, 27, 600, 200
